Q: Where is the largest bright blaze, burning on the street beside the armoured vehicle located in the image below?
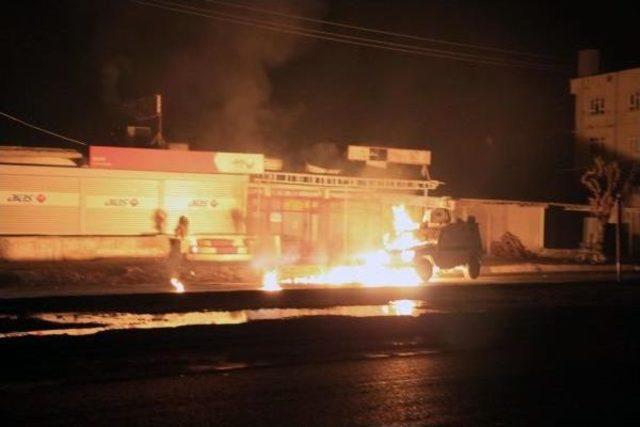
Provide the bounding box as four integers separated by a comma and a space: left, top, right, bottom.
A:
263, 205, 422, 290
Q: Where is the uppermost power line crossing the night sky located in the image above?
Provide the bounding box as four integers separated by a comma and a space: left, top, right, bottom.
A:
205, 0, 553, 59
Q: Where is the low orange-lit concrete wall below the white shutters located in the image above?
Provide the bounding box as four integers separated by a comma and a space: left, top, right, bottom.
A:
0, 236, 170, 261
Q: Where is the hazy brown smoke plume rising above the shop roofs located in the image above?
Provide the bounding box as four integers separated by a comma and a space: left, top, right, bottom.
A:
167, 0, 321, 153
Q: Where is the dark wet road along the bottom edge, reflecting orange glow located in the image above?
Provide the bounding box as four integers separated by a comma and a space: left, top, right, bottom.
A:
3, 344, 640, 425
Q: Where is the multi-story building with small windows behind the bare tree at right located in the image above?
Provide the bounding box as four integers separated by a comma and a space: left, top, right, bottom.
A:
571, 50, 640, 168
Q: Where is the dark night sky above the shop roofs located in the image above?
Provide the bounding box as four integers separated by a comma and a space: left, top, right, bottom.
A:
0, 0, 640, 199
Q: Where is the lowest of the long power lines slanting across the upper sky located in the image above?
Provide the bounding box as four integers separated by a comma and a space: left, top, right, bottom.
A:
131, 0, 568, 72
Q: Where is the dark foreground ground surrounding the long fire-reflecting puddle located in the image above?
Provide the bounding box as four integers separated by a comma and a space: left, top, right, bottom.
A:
0, 281, 640, 425
